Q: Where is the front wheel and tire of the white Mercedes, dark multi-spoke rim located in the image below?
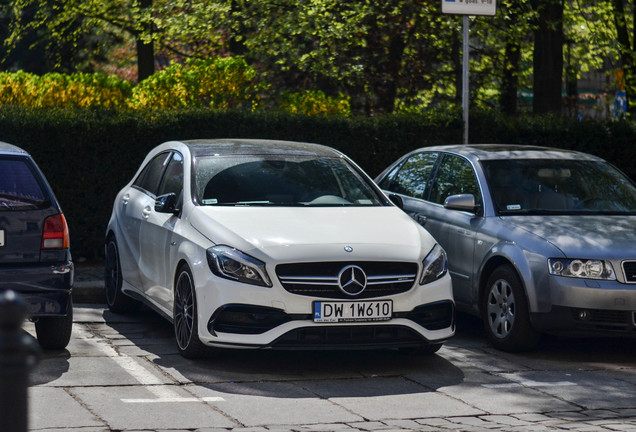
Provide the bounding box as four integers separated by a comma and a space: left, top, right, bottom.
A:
172, 265, 211, 359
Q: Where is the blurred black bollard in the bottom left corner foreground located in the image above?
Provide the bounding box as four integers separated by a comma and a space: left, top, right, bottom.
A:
0, 291, 39, 432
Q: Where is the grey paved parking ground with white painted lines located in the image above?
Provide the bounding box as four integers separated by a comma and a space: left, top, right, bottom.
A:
25, 304, 636, 432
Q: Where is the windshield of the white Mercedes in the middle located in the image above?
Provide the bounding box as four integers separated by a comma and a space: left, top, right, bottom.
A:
195, 155, 384, 206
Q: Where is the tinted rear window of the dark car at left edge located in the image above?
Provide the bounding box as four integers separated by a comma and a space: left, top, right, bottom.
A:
0, 158, 49, 211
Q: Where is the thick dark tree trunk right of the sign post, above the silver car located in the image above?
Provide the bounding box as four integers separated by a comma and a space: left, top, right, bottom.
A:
532, 0, 564, 114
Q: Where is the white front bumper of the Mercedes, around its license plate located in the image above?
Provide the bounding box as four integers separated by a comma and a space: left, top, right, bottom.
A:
195, 275, 455, 349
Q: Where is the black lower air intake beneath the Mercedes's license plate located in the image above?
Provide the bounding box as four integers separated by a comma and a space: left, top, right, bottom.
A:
272, 325, 426, 349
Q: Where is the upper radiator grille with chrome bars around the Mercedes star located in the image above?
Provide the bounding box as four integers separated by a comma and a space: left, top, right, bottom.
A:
276, 261, 418, 299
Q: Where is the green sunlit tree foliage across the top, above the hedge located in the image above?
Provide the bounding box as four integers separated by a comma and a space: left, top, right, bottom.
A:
0, 0, 636, 115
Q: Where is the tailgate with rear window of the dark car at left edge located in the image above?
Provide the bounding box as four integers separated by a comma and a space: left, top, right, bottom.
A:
0, 155, 59, 264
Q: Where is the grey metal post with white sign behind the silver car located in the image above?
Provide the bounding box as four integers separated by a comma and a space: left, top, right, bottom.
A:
442, 0, 497, 144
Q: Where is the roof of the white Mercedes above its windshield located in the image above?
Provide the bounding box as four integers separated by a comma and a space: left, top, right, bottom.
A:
171, 138, 343, 157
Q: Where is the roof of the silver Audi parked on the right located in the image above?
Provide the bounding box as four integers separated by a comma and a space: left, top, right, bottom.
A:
413, 144, 602, 161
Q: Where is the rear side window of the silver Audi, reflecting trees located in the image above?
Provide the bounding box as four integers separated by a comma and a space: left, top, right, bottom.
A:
380, 153, 437, 199
